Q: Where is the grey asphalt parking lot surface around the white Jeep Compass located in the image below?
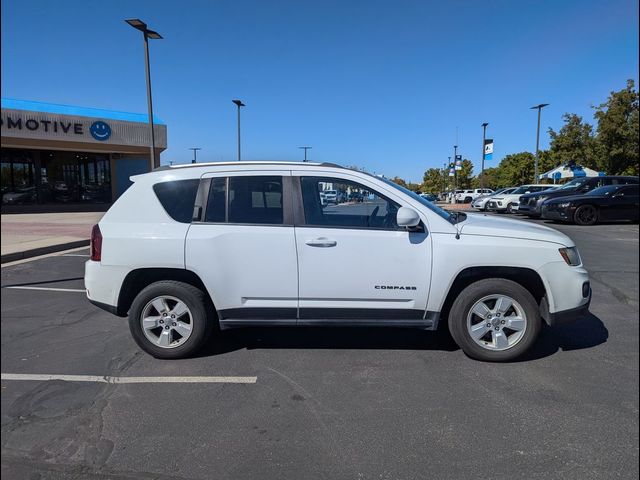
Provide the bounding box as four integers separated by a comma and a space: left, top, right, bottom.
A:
1, 217, 638, 479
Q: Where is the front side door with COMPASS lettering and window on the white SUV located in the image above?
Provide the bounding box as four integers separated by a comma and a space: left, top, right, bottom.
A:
293, 171, 431, 321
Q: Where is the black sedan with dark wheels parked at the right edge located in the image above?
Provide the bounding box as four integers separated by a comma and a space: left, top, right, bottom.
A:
541, 184, 640, 225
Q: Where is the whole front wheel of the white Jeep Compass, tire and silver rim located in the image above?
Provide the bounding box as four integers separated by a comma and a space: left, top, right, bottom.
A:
449, 278, 541, 362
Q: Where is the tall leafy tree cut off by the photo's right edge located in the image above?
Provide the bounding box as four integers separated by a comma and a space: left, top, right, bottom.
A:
594, 80, 639, 175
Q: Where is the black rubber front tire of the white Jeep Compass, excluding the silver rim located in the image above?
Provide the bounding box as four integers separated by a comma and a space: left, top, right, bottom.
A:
448, 278, 542, 362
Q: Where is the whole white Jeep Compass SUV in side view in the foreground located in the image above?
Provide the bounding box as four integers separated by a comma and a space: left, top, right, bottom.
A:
85, 162, 591, 361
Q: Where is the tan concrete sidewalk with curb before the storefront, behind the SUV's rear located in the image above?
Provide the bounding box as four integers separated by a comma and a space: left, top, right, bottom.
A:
0, 212, 104, 263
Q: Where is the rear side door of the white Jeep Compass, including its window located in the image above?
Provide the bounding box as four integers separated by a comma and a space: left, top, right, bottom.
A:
185, 171, 298, 320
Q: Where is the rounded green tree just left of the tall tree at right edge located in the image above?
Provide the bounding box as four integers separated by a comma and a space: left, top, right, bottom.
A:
540, 113, 598, 173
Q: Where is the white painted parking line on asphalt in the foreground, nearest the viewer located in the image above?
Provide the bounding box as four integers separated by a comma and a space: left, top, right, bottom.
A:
0, 373, 258, 384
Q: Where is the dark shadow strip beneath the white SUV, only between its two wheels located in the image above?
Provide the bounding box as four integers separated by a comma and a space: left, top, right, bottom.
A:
197, 327, 459, 357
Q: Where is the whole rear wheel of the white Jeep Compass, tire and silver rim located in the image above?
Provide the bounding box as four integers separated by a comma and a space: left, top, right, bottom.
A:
129, 280, 215, 359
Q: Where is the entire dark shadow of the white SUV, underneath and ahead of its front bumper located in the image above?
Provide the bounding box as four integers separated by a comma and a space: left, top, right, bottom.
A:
196, 313, 609, 362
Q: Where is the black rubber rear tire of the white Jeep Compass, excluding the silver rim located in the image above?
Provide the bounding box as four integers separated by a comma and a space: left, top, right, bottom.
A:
129, 280, 217, 359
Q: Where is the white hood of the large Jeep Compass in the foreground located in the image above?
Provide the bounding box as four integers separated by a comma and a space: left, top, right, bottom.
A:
459, 213, 574, 247
